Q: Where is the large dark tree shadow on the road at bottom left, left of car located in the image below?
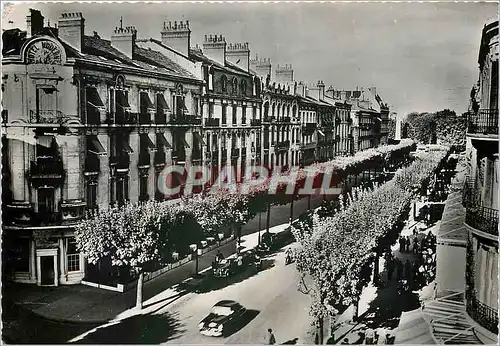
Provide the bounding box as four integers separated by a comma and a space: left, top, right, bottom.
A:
75, 313, 186, 344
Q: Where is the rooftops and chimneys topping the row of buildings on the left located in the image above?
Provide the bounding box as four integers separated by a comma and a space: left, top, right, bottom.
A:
2, 9, 387, 109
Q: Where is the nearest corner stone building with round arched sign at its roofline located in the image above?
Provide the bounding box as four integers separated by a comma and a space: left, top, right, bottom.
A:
2, 10, 203, 285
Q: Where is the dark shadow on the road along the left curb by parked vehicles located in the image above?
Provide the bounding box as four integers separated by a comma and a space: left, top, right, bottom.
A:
185, 259, 274, 293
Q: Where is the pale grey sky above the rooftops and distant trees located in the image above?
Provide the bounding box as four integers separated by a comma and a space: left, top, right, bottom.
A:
2, 2, 498, 115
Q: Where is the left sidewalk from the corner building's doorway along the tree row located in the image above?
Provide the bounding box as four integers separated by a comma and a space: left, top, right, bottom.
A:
2, 224, 288, 323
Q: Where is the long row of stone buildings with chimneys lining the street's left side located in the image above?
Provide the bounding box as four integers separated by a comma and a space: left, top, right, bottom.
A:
2, 10, 388, 285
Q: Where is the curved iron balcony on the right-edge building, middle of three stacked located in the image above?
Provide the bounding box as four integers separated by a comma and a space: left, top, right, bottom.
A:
462, 181, 498, 237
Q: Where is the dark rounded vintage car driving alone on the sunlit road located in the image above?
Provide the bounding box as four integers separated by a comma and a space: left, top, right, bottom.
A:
198, 300, 247, 336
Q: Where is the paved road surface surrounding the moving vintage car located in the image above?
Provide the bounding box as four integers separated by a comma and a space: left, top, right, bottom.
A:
73, 247, 313, 344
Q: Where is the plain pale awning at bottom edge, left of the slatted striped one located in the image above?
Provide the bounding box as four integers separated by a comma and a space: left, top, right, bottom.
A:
394, 308, 436, 345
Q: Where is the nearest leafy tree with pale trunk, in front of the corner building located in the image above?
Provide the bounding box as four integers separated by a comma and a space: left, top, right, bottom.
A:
75, 202, 187, 308
